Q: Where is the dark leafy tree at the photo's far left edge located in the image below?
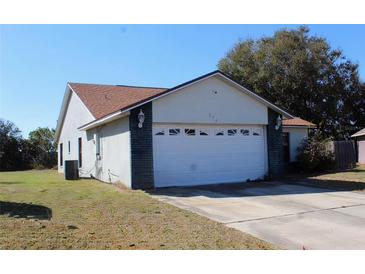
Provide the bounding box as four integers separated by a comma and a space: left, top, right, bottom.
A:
0, 119, 32, 170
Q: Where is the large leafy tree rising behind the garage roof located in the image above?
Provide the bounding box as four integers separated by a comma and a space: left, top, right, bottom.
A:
218, 26, 365, 139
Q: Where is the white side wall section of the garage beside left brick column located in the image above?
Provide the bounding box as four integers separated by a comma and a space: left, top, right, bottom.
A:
88, 117, 132, 188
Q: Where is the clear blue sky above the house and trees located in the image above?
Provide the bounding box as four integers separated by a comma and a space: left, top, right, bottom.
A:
0, 25, 365, 137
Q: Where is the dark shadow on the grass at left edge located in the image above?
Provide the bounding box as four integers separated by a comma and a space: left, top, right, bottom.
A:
0, 201, 52, 220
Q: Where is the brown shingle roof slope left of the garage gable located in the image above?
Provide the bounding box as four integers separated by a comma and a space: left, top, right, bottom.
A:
69, 83, 167, 119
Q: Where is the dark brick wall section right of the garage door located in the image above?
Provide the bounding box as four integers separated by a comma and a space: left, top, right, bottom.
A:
266, 109, 284, 178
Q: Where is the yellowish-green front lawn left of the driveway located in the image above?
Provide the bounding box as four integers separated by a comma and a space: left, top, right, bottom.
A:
0, 171, 275, 249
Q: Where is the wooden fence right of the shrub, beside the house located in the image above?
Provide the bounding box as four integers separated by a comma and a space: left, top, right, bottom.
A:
329, 140, 356, 169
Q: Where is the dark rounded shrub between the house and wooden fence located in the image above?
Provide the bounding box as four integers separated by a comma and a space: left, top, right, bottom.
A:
297, 134, 335, 172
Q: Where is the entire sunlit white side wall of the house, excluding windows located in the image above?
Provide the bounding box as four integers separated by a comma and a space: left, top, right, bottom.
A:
58, 90, 131, 188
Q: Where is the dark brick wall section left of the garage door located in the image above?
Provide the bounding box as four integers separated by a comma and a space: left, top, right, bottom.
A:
129, 102, 154, 189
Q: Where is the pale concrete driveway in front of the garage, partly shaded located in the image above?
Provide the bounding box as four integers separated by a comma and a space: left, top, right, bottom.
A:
152, 182, 365, 249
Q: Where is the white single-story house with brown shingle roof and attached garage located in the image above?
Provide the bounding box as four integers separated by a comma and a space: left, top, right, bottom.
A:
56, 71, 313, 189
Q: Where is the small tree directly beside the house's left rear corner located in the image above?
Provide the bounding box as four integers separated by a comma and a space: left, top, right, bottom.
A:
28, 127, 57, 168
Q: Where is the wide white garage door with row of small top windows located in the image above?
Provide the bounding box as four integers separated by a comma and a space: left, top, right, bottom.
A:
153, 125, 266, 187
